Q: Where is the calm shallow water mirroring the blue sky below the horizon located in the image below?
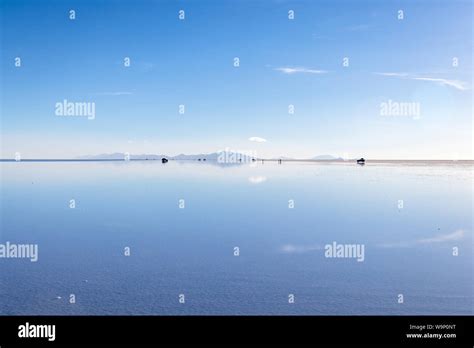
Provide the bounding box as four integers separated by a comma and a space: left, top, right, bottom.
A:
0, 161, 473, 315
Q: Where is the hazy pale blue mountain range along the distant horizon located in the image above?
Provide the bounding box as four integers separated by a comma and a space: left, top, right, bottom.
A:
77, 152, 343, 161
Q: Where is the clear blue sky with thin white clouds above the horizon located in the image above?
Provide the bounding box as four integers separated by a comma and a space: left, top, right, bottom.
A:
0, 0, 473, 159
